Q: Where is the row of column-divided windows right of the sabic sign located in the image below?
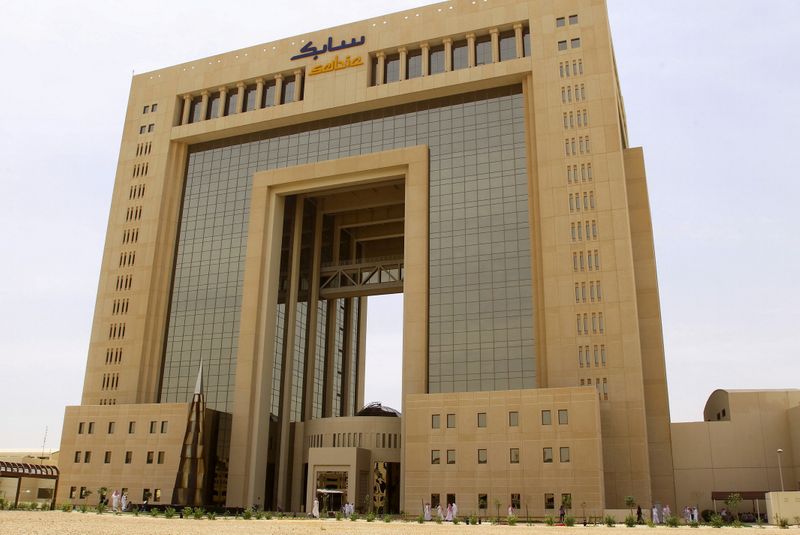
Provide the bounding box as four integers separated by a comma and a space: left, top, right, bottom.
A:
370, 24, 531, 86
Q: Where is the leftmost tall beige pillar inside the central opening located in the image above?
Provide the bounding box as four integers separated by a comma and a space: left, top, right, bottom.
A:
275, 196, 304, 510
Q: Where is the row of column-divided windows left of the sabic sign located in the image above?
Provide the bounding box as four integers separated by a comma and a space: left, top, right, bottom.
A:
181, 70, 303, 124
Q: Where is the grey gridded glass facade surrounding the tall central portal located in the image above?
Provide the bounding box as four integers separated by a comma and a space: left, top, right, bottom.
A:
161, 86, 535, 414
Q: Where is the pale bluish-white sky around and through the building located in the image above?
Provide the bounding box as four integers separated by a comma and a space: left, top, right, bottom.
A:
0, 0, 800, 450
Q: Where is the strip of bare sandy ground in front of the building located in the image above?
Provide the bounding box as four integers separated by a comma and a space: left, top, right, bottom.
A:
0, 511, 800, 535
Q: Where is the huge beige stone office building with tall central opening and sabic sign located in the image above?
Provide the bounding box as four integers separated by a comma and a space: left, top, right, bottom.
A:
58, 0, 675, 516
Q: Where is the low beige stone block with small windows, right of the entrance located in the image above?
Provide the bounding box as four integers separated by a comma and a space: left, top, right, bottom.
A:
403, 388, 604, 517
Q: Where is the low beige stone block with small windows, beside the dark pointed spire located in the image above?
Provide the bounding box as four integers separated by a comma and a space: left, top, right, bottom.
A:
56, 403, 190, 504
